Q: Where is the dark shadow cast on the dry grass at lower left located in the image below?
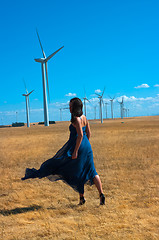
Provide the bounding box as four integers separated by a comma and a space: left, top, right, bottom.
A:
0, 205, 42, 216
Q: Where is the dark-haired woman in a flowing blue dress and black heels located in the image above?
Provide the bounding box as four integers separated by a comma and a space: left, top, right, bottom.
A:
22, 98, 105, 205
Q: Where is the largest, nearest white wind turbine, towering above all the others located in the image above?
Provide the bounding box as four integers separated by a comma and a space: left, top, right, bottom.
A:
34, 30, 64, 126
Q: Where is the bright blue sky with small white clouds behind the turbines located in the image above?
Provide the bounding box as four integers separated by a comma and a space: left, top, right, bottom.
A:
0, 0, 159, 125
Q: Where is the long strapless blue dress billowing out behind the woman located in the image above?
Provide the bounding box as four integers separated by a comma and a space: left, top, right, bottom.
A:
22, 124, 97, 193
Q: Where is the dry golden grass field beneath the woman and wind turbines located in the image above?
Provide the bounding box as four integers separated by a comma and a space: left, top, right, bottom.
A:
0, 116, 159, 240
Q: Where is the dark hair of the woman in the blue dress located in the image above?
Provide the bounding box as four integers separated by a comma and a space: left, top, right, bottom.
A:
70, 98, 83, 123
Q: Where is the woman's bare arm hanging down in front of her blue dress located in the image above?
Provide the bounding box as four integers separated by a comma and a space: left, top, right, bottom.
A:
72, 117, 83, 159
